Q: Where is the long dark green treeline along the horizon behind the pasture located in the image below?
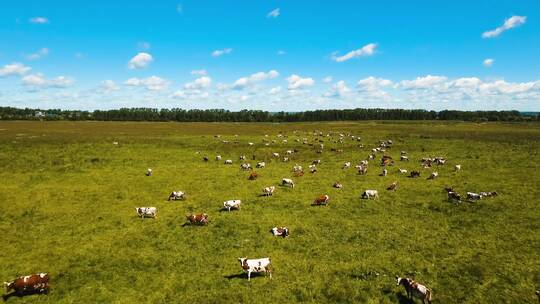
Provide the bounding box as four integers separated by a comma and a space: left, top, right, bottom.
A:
0, 107, 540, 122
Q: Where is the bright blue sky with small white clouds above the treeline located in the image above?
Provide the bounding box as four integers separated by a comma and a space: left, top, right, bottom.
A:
0, 0, 540, 111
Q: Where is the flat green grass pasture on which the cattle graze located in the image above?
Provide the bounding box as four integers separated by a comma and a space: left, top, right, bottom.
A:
0, 122, 540, 303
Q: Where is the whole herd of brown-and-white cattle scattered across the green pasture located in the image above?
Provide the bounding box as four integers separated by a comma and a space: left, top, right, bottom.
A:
4, 132, 510, 303
